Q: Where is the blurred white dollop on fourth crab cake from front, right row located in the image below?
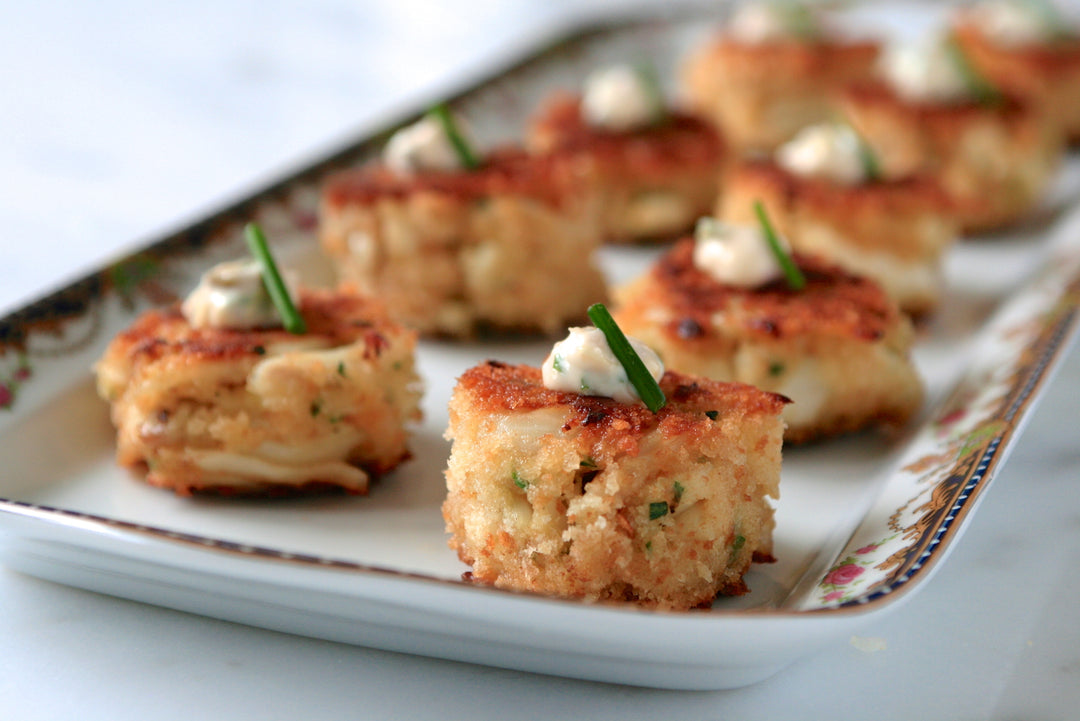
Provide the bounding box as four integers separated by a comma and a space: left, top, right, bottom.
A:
880, 38, 972, 103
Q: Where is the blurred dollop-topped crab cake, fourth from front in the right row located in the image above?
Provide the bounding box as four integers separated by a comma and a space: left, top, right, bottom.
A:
843, 35, 1063, 232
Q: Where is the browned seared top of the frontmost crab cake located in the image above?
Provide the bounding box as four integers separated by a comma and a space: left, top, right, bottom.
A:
458, 361, 788, 433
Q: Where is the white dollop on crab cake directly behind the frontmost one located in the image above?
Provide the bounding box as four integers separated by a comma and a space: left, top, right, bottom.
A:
693, 218, 791, 288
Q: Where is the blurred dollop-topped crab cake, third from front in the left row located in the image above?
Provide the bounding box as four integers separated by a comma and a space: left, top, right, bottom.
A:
527, 66, 725, 242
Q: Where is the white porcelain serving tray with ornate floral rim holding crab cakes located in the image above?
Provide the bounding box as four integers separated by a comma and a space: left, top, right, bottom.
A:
0, 2, 1080, 689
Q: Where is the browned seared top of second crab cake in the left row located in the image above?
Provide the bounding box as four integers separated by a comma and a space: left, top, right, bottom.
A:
323, 148, 577, 207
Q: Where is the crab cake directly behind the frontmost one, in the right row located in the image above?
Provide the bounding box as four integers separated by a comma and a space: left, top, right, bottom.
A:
615, 227, 922, 443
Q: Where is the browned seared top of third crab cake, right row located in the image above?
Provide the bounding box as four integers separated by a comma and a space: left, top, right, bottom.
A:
730, 160, 951, 212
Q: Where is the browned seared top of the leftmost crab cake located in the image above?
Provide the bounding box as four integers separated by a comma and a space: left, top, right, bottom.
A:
106, 289, 402, 362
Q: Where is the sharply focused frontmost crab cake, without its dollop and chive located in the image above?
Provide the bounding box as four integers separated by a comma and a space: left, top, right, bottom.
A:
443, 362, 784, 610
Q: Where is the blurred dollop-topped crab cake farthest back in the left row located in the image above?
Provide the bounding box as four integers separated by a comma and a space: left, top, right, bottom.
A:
681, 2, 879, 153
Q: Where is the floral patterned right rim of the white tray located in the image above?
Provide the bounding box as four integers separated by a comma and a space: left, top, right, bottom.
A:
808, 253, 1080, 608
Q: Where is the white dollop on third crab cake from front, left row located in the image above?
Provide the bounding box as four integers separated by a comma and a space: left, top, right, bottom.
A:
581, 65, 664, 131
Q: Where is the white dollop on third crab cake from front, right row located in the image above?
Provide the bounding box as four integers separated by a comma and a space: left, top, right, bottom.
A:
775, 123, 867, 186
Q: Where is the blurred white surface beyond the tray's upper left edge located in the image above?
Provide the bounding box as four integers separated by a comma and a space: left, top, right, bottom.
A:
0, 0, 639, 312
